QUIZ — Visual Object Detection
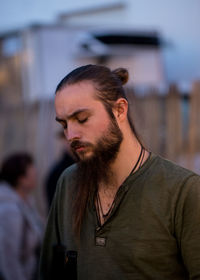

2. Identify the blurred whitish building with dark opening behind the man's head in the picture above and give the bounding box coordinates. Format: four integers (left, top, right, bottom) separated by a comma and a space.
0, 28, 165, 104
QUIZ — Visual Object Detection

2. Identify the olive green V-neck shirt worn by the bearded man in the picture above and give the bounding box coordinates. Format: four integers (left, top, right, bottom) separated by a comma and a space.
40, 154, 200, 280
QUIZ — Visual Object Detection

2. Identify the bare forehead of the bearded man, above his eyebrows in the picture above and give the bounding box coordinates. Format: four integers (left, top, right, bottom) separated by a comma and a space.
55, 81, 103, 116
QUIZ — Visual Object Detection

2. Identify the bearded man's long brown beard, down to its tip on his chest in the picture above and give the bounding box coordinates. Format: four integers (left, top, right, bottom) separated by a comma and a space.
71, 111, 123, 237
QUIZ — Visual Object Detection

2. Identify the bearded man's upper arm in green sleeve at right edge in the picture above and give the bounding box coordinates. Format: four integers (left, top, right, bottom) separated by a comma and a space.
176, 176, 200, 279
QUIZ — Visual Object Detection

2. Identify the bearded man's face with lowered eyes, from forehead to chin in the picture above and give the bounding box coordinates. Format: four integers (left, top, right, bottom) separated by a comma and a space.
55, 81, 122, 162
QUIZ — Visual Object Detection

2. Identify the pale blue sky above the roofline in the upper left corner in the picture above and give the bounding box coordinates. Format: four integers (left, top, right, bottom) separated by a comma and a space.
0, 0, 115, 33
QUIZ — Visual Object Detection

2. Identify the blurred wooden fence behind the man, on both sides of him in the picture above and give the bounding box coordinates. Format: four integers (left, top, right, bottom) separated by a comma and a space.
0, 82, 200, 214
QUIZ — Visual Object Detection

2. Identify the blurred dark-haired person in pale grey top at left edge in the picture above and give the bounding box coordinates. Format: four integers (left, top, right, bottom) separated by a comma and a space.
0, 152, 43, 280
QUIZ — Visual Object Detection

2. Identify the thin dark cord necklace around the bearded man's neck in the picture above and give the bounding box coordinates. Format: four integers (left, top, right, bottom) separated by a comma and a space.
96, 146, 145, 223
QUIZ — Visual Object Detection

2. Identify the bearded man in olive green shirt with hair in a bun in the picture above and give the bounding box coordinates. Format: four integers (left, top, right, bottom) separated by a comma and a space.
41, 65, 200, 280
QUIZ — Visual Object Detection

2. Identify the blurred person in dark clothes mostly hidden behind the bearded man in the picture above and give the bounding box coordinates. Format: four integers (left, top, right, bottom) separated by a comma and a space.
46, 130, 74, 209
